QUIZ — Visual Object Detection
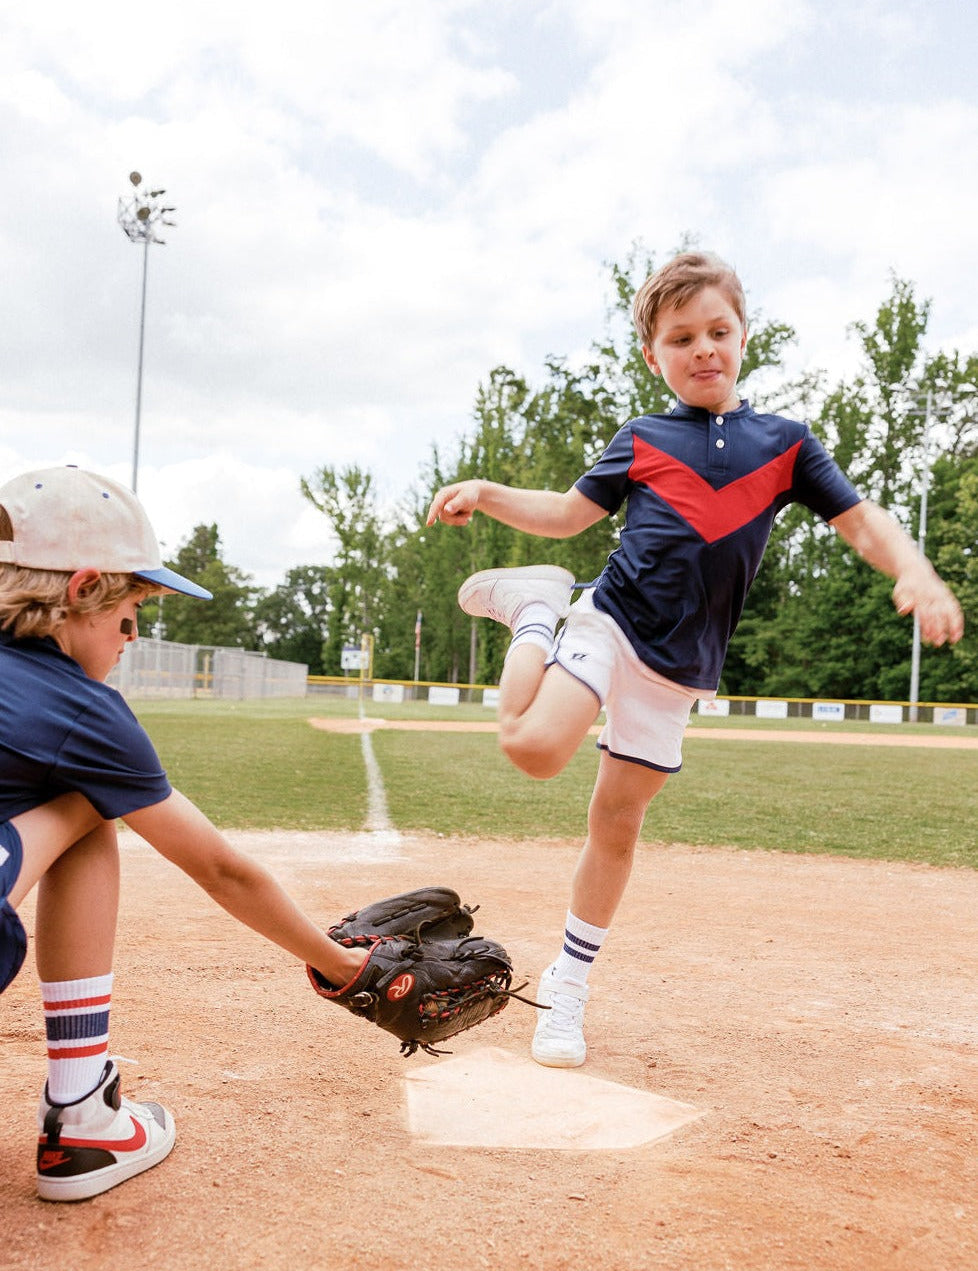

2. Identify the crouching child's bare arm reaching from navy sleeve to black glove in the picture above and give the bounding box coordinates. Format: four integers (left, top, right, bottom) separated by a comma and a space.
123, 791, 364, 984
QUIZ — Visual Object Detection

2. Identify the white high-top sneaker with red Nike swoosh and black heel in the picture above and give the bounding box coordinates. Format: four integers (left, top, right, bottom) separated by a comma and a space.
37, 1060, 176, 1200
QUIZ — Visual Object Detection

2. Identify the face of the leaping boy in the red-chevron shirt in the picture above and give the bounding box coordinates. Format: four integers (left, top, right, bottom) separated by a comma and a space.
642, 287, 747, 414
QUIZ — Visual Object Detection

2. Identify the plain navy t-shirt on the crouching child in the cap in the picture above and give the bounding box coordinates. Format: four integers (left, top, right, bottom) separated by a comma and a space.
0, 632, 170, 821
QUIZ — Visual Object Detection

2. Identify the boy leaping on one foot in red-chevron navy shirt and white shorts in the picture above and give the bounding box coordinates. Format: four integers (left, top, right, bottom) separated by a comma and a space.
427, 253, 964, 1068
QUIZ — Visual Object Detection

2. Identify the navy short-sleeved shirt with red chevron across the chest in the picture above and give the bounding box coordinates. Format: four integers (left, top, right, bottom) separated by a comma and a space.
576, 402, 861, 690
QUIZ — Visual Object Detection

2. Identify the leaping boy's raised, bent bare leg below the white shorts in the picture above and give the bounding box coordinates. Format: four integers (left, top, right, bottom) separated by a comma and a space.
499, 644, 600, 780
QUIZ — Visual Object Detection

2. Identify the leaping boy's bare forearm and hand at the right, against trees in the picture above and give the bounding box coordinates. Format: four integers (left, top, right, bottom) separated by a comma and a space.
830, 498, 964, 646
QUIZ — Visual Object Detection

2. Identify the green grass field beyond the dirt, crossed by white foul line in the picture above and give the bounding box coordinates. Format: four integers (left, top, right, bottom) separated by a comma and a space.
134, 697, 978, 868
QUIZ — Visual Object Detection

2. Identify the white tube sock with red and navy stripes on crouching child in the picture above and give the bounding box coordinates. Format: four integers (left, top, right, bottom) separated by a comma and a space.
41, 974, 112, 1103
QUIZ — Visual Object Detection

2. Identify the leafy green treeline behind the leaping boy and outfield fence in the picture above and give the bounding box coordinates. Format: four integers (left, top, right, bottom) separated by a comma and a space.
146, 252, 978, 702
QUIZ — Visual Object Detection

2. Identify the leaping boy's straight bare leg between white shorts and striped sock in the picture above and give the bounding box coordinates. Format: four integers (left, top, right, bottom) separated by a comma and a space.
571, 751, 669, 927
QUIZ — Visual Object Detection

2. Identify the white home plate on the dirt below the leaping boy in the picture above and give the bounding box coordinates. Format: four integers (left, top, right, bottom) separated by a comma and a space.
404, 1047, 703, 1152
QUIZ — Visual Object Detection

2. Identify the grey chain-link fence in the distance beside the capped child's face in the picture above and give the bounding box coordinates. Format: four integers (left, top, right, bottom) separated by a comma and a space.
107, 639, 309, 699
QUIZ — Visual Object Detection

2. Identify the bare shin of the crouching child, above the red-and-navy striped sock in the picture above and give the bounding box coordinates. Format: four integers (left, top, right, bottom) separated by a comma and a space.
34, 821, 120, 982
